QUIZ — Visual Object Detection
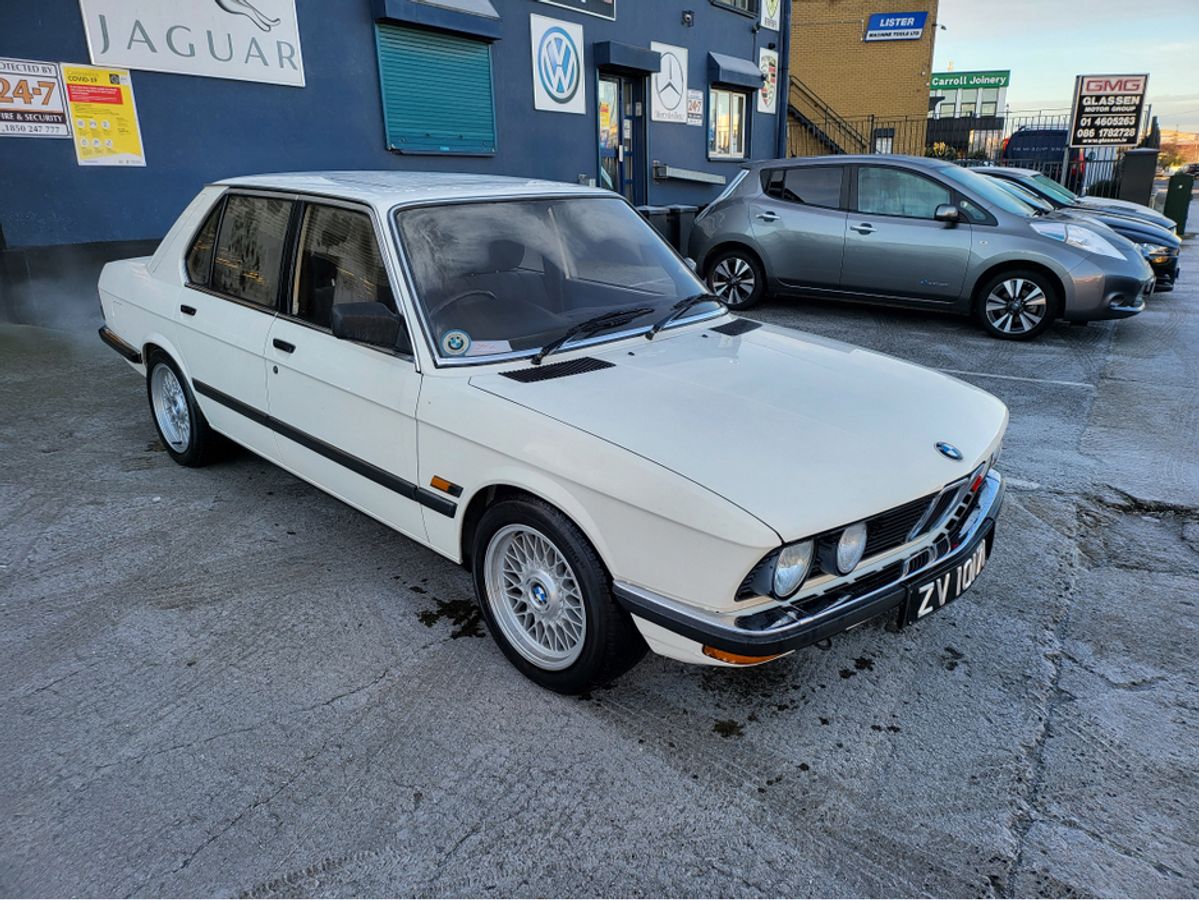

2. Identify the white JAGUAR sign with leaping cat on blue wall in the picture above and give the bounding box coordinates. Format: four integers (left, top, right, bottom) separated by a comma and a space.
79, 0, 303, 87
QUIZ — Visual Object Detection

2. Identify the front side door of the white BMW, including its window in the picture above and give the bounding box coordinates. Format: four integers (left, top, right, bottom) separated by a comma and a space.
266, 200, 426, 540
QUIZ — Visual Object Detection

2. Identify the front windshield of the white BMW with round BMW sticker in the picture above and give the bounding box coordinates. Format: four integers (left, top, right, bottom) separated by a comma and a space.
396, 197, 721, 358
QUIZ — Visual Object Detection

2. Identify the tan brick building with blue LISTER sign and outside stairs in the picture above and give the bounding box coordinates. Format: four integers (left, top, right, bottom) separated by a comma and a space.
789, 0, 938, 156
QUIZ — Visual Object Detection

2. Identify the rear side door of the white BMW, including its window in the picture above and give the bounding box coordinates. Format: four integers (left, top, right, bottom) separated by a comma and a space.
174, 192, 295, 458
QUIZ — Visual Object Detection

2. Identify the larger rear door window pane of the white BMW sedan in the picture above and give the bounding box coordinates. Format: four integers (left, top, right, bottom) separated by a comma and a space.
211, 194, 293, 309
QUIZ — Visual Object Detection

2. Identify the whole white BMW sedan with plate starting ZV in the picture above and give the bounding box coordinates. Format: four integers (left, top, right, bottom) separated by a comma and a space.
100, 171, 1007, 693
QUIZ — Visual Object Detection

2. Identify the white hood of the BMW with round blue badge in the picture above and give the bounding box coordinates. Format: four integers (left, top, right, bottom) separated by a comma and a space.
470, 320, 1007, 540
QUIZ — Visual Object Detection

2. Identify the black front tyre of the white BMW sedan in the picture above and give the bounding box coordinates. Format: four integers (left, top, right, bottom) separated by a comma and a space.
471, 499, 646, 694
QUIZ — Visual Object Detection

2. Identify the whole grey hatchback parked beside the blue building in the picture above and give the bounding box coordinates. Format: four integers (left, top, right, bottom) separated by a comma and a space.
689, 156, 1153, 340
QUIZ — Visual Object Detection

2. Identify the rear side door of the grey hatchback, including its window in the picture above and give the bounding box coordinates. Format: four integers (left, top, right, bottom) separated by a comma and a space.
749, 165, 845, 288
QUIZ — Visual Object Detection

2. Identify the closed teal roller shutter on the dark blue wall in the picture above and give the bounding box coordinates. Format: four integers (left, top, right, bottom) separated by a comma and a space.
375, 24, 495, 156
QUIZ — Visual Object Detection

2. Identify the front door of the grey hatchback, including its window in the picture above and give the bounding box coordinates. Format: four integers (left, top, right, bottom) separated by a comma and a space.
842, 165, 972, 301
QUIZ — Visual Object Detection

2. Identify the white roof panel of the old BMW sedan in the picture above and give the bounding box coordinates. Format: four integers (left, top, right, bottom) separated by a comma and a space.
216, 170, 604, 207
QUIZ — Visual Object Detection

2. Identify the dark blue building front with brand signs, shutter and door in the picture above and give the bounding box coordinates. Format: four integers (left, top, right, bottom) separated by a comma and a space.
0, 0, 789, 250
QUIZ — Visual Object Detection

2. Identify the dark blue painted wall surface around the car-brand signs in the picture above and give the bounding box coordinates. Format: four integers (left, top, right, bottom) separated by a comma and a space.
0, 0, 789, 247
